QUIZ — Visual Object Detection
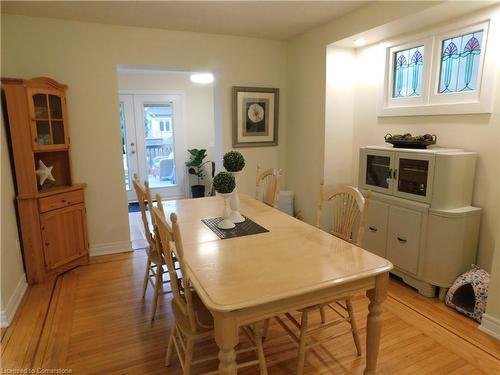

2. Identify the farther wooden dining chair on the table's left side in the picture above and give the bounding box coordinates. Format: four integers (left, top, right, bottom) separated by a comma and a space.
132, 174, 171, 320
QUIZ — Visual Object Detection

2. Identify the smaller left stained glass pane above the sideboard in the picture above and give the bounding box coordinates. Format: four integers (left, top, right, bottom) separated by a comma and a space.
392, 46, 424, 98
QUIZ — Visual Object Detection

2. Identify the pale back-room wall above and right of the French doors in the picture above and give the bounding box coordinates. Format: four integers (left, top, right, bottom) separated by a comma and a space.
118, 69, 216, 192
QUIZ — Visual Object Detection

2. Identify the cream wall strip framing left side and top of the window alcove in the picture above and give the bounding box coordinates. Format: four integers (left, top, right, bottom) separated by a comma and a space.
285, 1, 436, 228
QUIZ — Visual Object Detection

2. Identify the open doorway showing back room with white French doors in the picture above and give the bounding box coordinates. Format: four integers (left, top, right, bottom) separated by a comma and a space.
117, 65, 223, 253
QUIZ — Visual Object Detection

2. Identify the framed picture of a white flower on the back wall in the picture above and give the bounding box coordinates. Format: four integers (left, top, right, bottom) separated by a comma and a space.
233, 86, 279, 148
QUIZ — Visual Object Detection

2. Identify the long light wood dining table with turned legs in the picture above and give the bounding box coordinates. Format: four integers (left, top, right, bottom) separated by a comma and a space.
163, 194, 392, 375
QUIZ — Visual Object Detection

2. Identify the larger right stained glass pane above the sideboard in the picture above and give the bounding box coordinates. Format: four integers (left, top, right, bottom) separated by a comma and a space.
439, 30, 484, 94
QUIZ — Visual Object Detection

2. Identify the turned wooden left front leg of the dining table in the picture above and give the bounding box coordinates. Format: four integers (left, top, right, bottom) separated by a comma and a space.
214, 313, 239, 375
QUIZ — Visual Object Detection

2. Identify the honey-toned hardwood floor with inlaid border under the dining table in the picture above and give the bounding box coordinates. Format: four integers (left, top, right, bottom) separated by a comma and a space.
1, 251, 500, 375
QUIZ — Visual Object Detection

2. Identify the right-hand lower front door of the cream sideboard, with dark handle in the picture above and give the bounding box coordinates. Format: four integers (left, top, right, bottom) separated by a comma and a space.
387, 206, 422, 275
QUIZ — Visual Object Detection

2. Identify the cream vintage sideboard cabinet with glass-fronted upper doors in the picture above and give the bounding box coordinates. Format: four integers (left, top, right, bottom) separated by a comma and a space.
359, 146, 481, 299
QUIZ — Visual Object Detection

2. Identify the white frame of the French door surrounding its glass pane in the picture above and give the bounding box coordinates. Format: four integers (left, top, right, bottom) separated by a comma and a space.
119, 90, 188, 201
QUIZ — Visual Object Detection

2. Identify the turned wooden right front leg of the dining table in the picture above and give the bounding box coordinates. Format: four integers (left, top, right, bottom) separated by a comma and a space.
364, 272, 389, 375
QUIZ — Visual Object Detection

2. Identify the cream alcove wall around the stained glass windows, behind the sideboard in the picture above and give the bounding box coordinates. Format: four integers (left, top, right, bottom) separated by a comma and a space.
352, 7, 500, 270
